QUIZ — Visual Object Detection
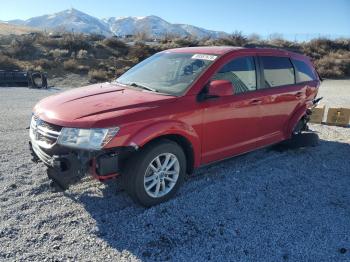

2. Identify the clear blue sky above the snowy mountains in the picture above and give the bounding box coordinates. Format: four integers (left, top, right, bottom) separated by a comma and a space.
0, 0, 350, 40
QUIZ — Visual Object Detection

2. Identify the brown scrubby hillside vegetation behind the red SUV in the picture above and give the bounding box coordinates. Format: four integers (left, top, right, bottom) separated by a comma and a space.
0, 33, 350, 82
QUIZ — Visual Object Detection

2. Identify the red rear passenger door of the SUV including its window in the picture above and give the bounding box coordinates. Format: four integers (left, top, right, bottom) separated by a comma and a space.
257, 55, 304, 146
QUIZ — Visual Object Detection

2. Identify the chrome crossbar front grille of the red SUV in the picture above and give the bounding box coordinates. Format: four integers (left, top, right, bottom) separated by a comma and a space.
30, 115, 62, 149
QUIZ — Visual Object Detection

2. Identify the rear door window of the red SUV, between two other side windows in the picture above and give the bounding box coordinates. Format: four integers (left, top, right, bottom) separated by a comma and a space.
260, 56, 295, 88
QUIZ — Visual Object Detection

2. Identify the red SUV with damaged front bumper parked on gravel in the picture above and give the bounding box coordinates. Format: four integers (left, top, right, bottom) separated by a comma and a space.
30, 47, 320, 206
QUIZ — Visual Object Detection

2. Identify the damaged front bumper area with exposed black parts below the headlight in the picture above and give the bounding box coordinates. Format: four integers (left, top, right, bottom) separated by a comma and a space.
29, 140, 135, 190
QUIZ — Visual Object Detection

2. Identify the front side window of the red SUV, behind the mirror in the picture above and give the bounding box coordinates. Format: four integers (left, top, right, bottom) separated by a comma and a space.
213, 57, 256, 94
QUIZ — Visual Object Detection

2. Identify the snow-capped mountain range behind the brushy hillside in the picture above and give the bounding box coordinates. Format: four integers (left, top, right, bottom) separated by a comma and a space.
8, 9, 227, 38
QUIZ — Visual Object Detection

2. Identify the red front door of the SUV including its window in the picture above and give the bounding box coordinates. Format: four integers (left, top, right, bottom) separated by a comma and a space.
202, 56, 260, 164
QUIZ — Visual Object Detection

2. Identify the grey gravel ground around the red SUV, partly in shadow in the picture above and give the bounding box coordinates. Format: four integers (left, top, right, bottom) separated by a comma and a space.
0, 81, 350, 261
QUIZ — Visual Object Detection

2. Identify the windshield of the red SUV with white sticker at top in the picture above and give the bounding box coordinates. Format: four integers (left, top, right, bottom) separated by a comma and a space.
116, 52, 216, 95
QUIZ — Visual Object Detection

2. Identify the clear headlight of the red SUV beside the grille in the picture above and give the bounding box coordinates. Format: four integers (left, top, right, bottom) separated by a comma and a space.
57, 127, 119, 150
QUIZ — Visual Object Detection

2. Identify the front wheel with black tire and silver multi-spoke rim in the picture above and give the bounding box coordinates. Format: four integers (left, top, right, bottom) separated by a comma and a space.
123, 139, 186, 207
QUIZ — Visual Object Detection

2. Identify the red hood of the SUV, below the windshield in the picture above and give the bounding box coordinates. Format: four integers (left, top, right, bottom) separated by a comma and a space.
34, 83, 177, 127
